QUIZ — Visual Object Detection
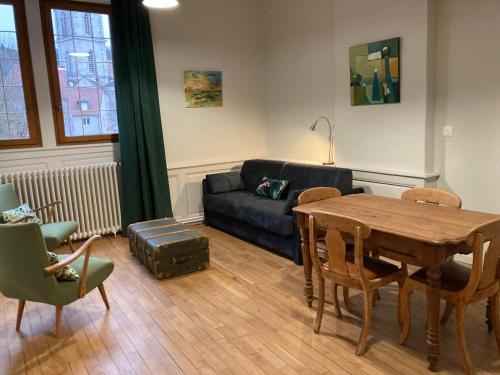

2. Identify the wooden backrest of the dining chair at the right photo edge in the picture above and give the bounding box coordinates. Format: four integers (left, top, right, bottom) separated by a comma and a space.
464, 219, 500, 297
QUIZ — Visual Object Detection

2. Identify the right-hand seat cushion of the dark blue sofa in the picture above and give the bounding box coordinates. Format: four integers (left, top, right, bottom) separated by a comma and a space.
238, 196, 294, 236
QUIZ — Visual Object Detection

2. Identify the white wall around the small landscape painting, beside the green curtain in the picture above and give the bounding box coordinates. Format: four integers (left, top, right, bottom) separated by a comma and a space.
150, 0, 266, 168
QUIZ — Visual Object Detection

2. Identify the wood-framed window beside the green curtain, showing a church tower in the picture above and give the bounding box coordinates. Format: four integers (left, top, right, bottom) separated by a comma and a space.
40, 0, 118, 144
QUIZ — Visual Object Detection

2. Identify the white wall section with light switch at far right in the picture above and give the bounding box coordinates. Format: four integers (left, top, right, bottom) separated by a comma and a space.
435, 0, 500, 213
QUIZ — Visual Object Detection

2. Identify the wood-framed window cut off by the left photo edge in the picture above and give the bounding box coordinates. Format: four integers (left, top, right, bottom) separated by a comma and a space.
0, 0, 41, 148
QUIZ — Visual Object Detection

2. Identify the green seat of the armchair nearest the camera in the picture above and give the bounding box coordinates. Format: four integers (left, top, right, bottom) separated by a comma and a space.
50, 254, 115, 306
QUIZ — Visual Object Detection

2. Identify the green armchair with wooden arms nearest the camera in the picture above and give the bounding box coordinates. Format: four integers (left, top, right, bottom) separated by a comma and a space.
0, 223, 114, 336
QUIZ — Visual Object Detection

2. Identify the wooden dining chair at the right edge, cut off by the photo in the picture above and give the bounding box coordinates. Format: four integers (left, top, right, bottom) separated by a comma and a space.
399, 220, 500, 374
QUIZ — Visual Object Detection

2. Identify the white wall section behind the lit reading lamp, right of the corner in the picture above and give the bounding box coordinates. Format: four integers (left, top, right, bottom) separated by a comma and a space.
263, 0, 335, 161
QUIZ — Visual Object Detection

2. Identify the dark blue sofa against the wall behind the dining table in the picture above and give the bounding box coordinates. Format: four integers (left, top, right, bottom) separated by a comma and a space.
203, 159, 363, 264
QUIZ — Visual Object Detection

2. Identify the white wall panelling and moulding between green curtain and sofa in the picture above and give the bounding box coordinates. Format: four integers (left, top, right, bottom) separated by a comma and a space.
168, 160, 243, 223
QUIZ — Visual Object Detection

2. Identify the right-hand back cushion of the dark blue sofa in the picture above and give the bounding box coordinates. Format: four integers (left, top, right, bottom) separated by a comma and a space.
279, 163, 352, 195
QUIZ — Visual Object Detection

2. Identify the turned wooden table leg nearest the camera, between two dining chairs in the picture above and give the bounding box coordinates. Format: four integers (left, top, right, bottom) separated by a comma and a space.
426, 264, 441, 371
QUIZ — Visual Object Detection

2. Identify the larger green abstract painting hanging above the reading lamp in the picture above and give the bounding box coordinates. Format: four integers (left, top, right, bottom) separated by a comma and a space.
349, 38, 401, 105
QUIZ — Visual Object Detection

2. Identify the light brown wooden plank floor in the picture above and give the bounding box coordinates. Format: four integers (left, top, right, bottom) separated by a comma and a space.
0, 226, 500, 375
